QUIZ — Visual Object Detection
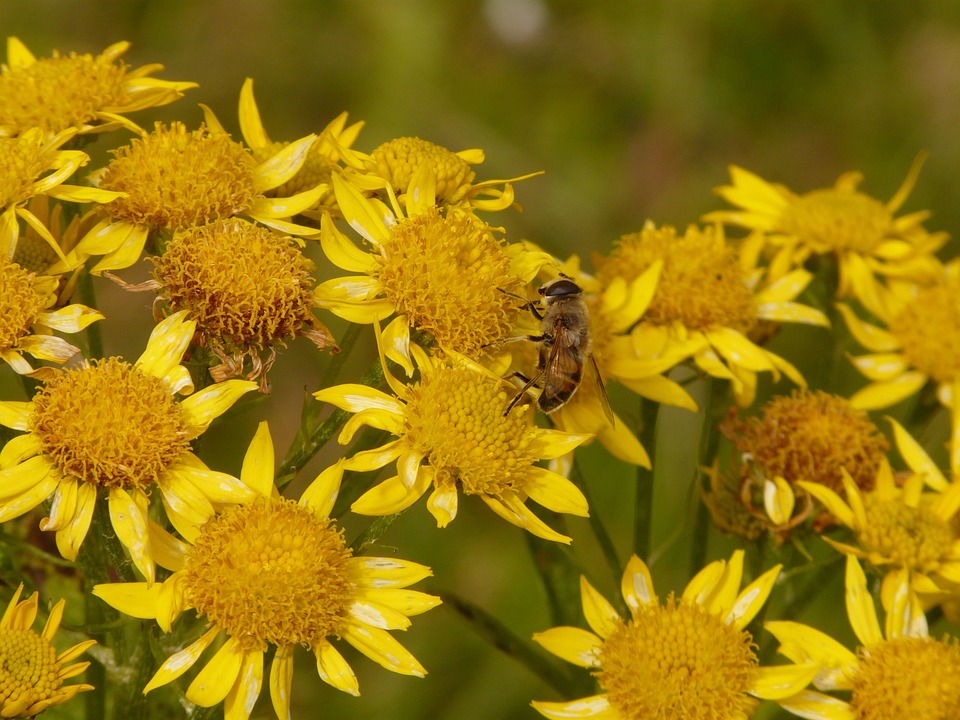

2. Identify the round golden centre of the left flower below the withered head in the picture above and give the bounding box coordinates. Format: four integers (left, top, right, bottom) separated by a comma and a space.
31, 358, 191, 489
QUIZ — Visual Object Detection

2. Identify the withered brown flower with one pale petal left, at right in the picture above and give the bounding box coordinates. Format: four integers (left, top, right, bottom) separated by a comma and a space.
720, 390, 889, 539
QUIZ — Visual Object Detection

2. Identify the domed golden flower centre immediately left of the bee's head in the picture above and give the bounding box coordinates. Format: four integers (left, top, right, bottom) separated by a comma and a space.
376, 208, 522, 357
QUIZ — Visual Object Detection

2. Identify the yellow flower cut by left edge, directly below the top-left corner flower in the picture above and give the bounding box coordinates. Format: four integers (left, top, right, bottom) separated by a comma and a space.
0, 127, 123, 257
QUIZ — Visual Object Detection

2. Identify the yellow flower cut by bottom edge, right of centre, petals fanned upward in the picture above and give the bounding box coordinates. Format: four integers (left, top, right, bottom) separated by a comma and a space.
532, 550, 818, 720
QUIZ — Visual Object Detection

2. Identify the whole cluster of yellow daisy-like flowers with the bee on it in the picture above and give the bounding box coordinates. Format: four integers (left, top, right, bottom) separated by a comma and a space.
0, 32, 960, 720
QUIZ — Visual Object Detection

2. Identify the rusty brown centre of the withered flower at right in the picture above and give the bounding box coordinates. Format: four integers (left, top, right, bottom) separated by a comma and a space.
721, 390, 889, 492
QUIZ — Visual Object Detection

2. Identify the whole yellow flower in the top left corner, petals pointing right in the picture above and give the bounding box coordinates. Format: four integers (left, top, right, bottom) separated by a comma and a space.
0, 37, 197, 136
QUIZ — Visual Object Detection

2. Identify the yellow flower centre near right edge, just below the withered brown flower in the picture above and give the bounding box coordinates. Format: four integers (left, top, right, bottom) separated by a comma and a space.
859, 494, 956, 572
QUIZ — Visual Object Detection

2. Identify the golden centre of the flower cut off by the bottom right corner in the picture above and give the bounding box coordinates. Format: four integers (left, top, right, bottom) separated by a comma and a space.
850, 637, 960, 720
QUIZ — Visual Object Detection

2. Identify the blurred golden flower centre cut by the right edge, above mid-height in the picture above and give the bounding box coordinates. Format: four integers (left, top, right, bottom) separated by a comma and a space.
890, 280, 960, 383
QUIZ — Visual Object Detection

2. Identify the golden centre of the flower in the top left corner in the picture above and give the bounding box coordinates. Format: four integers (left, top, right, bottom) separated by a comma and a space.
0, 52, 126, 136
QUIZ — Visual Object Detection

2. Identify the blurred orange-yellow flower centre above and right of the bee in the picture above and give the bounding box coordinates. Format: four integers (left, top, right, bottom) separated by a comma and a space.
595, 224, 757, 333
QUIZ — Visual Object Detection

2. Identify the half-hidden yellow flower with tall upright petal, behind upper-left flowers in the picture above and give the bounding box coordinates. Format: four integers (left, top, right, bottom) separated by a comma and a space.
201, 78, 365, 214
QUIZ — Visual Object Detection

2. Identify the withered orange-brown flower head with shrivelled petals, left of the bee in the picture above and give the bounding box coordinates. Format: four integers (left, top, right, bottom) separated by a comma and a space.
137, 218, 336, 392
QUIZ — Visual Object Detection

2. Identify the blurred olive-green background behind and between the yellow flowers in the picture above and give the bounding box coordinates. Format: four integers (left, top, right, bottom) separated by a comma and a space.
0, 0, 960, 720
